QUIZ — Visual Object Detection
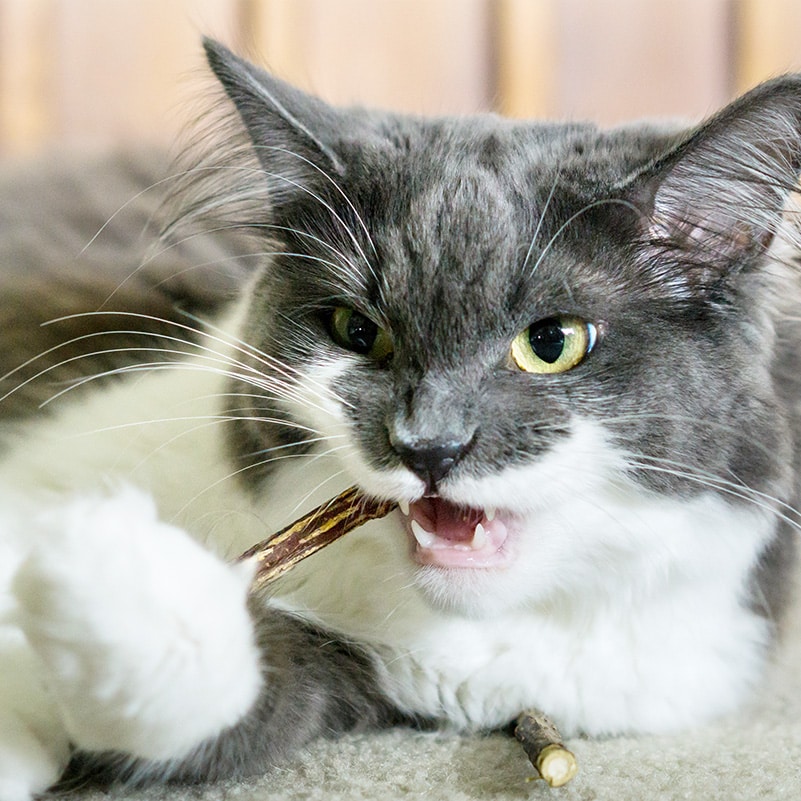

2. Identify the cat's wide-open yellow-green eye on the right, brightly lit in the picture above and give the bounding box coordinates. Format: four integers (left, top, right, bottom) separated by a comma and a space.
511, 315, 597, 373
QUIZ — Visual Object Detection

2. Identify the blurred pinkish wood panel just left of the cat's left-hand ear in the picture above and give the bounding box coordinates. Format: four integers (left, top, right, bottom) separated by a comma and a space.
47, 0, 236, 144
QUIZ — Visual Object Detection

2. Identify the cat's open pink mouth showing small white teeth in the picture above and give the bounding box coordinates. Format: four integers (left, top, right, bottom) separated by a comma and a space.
401, 497, 511, 568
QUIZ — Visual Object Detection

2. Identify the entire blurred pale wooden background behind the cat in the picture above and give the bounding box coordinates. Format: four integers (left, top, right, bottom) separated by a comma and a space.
0, 0, 801, 155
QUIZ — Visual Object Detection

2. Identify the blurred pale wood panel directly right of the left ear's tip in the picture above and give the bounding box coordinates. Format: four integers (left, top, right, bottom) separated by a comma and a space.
246, 0, 493, 114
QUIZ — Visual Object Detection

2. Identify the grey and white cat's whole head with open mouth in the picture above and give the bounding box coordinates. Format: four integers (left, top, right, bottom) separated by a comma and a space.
194, 43, 801, 608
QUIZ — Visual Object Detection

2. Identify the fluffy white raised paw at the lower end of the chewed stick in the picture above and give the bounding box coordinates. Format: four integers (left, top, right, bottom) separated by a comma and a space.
14, 488, 261, 759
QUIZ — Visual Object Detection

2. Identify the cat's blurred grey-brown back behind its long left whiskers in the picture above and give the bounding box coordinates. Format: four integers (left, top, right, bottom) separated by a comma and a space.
0, 149, 250, 420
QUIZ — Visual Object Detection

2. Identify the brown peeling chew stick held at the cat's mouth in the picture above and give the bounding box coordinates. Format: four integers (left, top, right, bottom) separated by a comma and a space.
239, 487, 397, 590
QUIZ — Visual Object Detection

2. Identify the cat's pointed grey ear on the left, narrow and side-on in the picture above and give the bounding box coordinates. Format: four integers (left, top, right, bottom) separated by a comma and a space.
203, 39, 370, 206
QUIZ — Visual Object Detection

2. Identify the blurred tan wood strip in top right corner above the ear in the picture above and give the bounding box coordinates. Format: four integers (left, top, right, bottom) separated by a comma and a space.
734, 0, 801, 92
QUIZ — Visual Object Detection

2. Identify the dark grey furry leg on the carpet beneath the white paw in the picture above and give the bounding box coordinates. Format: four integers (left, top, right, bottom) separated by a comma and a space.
59, 605, 406, 789
